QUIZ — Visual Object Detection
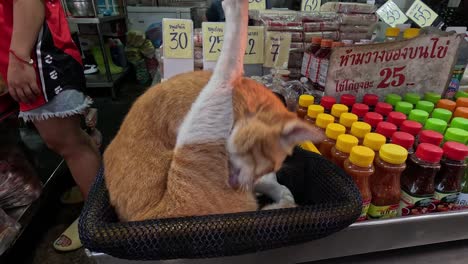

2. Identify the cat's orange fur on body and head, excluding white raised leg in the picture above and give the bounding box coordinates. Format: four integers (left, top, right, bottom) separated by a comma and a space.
104, 71, 322, 221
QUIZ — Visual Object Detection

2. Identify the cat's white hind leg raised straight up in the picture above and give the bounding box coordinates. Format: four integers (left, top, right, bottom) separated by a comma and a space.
176, 0, 249, 146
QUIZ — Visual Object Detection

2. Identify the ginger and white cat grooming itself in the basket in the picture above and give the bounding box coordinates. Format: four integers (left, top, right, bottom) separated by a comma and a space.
104, 0, 323, 221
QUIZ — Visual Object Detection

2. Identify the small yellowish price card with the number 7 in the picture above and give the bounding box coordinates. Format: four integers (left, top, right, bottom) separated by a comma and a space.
263, 31, 291, 69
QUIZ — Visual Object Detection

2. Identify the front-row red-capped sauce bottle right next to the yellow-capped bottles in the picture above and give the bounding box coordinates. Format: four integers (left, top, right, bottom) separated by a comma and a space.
399, 143, 443, 216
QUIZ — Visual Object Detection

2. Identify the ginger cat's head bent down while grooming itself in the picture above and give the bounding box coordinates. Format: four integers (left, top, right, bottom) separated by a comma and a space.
227, 114, 324, 190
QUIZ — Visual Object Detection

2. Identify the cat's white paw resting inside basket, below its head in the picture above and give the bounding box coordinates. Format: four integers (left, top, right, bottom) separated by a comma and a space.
254, 173, 296, 210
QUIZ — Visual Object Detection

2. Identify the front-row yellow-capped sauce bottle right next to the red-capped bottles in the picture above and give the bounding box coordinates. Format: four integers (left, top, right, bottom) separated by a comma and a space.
367, 144, 408, 219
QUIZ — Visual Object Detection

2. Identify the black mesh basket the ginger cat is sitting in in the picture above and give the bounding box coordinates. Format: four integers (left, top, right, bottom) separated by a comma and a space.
79, 148, 362, 260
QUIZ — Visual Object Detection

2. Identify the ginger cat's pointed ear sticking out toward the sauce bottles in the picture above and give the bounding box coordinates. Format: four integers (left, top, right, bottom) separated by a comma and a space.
280, 119, 325, 154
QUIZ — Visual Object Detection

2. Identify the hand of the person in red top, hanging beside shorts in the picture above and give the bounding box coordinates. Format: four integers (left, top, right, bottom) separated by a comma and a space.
7, 54, 41, 104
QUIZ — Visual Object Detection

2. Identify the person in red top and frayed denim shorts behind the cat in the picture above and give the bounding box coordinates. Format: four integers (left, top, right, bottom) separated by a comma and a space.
0, 0, 101, 250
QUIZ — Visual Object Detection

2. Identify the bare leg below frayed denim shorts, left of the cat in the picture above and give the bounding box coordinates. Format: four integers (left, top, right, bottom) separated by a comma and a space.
34, 116, 101, 199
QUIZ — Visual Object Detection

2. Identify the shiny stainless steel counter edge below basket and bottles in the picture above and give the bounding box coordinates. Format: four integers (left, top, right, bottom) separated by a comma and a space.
87, 211, 468, 264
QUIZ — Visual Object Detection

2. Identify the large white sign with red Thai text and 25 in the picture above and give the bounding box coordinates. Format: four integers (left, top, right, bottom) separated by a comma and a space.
325, 34, 463, 99
